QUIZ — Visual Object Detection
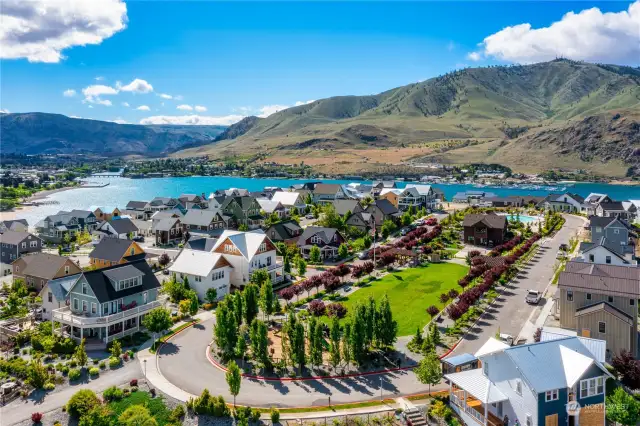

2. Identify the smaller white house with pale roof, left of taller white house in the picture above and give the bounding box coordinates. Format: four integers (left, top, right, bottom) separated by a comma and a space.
169, 249, 233, 300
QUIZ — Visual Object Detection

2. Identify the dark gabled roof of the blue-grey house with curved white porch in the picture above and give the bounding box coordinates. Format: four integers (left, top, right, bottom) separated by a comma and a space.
83, 260, 160, 303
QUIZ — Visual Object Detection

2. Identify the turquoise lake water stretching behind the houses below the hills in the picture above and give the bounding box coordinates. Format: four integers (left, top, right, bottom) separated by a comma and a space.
10, 176, 640, 225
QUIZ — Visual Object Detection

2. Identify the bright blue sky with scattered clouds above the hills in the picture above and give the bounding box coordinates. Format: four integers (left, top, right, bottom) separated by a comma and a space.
0, 0, 640, 124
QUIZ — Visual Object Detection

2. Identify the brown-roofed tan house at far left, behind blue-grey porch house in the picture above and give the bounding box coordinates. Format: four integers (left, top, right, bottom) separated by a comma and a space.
11, 253, 82, 291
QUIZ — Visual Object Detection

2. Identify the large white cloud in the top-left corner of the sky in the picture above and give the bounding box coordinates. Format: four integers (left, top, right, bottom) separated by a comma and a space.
0, 0, 127, 63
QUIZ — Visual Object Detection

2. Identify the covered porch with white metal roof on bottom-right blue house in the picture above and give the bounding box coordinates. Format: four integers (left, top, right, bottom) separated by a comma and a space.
445, 369, 508, 426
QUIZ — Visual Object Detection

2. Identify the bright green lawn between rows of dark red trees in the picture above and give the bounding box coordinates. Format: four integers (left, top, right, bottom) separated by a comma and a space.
342, 263, 468, 336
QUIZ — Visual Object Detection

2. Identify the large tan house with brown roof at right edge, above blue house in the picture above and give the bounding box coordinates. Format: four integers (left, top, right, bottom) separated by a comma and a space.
556, 261, 640, 358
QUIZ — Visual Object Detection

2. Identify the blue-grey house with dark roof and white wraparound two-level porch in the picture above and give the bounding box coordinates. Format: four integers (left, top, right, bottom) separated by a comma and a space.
52, 260, 164, 347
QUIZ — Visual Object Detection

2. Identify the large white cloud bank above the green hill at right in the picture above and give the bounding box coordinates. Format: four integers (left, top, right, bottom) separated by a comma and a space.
468, 0, 640, 65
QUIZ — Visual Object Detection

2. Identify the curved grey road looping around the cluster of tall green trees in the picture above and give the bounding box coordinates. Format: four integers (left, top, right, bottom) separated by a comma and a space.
158, 320, 436, 407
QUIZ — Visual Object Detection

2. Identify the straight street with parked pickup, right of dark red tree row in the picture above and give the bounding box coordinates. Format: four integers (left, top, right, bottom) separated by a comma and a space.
455, 215, 584, 354
